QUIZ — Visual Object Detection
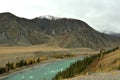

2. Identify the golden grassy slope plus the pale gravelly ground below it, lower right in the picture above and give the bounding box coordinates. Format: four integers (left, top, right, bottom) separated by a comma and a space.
65, 50, 120, 80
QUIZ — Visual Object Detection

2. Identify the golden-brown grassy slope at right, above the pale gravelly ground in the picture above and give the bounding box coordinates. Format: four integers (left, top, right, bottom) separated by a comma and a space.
83, 50, 120, 73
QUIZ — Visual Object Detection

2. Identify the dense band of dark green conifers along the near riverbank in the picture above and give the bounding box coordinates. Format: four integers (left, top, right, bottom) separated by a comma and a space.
52, 47, 119, 80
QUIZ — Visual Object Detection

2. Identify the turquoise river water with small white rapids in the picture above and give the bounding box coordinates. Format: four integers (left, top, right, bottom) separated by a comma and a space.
3, 56, 83, 80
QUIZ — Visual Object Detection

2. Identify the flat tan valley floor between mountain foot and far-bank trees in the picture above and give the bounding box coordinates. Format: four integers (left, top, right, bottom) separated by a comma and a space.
0, 45, 97, 66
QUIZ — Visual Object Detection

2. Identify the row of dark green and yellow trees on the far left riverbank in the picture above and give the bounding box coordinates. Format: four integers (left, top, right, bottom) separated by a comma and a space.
0, 56, 47, 74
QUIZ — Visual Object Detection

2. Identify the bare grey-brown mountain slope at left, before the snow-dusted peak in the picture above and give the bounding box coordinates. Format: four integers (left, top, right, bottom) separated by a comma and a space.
0, 13, 53, 45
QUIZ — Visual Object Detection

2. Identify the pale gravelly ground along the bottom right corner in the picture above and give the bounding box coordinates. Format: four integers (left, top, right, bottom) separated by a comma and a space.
65, 71, 120, 80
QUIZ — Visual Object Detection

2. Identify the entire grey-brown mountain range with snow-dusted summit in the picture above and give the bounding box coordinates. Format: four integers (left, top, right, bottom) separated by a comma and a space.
0, 13, 120, 48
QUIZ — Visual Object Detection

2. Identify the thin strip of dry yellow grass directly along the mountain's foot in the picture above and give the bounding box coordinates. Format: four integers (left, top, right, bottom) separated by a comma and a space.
0, 45, 95, 54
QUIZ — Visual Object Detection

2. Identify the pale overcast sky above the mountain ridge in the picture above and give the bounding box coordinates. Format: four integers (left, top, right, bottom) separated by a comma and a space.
0, 0, 120, 32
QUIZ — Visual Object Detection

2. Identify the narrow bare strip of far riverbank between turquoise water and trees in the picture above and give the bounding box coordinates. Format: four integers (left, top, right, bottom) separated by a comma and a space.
0, 55, 85, 80
